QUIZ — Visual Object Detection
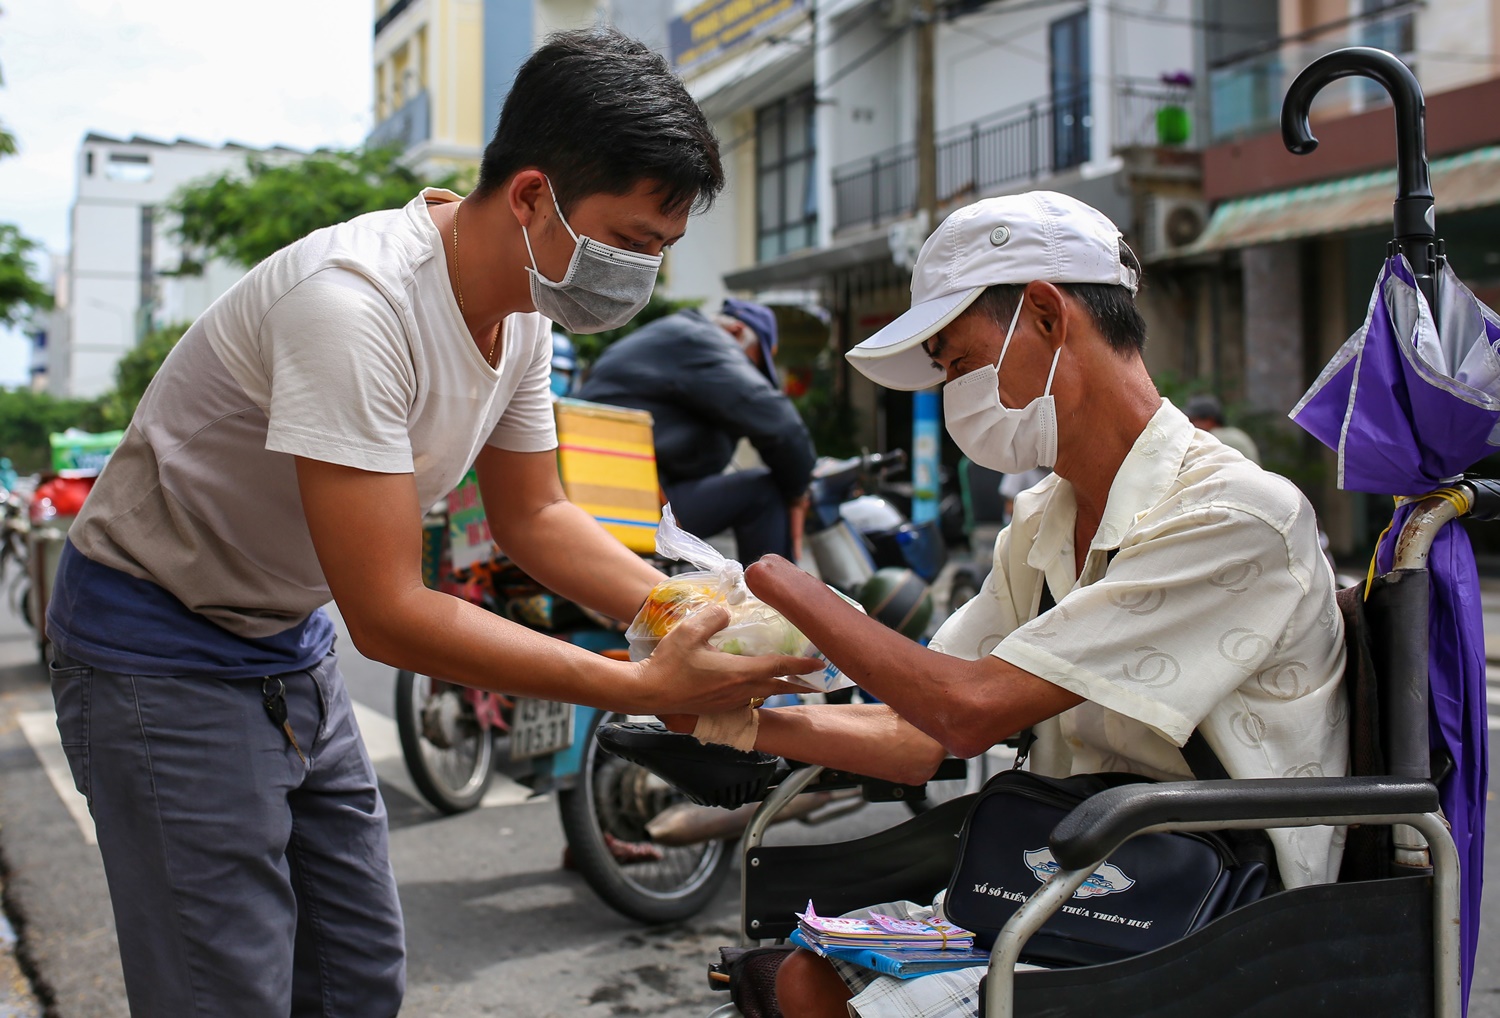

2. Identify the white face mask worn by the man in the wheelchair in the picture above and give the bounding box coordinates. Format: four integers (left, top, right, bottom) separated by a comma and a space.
942, 301, 1062, 474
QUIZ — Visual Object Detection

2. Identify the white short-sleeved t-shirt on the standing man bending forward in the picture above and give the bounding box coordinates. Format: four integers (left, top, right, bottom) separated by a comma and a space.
69, 189, 557, 637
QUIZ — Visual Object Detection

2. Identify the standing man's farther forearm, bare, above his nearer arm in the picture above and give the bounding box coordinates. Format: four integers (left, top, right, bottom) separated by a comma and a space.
491, 501, 665, 622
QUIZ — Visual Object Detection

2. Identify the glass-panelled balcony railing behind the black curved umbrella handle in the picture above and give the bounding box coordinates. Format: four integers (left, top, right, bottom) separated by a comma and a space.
1209, 4, 1416, 142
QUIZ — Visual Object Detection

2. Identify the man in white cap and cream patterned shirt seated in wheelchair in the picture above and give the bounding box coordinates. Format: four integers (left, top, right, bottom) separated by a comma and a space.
669, 192, 1349, 1018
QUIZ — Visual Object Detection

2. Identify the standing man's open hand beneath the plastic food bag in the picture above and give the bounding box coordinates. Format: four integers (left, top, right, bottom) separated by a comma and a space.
639, 604, 824, 714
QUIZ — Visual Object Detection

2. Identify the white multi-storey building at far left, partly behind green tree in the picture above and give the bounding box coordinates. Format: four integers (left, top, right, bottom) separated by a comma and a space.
47, 133, 300, 397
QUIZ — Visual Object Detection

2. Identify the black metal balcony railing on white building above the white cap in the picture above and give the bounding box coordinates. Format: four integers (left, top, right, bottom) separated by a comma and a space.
834, 82, 1188, 231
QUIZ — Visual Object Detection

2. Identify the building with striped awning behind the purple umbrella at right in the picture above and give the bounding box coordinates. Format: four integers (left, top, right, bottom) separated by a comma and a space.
1148, 0, 1500, 556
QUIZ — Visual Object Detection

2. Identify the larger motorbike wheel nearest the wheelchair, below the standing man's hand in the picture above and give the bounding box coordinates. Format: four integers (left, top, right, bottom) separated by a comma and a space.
558, 712, 732, 924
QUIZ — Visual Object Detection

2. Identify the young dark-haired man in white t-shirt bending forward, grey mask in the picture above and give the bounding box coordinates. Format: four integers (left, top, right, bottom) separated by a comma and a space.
48, 33, 812, 1018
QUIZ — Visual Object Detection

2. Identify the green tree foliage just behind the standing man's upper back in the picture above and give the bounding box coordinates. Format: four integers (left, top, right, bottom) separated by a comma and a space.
170, 147, 458, 274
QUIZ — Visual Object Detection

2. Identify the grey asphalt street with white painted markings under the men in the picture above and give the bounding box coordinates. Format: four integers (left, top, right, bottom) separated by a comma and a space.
0, 592, 1500, 1018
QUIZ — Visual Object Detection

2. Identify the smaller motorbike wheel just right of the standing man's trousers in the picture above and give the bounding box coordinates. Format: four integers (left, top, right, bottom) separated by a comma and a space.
396, 669, 495, 816
